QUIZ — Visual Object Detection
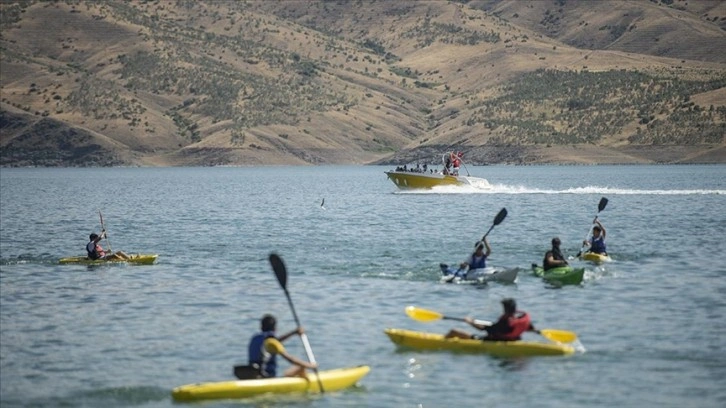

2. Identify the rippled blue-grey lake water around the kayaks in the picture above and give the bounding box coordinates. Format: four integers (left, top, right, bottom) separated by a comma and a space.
0, 165, 726, 408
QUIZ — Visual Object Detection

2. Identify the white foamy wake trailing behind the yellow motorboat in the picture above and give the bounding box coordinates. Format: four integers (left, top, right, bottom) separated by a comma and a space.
396, 184, 726, 195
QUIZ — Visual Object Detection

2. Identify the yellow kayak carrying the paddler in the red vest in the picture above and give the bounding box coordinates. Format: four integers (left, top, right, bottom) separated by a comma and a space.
384, 329, 575, 357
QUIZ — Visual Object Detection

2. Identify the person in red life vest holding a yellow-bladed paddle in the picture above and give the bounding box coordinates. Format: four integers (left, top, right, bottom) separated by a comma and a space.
446, 298, 539, 341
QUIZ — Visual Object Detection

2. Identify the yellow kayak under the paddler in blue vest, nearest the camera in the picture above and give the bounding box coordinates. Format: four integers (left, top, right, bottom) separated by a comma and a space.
171, 365, 370, 402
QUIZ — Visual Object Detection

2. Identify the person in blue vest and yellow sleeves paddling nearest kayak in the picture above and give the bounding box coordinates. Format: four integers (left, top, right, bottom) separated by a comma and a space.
248, 314, 318, 378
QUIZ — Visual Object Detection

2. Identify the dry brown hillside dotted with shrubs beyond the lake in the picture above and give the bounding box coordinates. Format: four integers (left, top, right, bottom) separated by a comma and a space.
0, 0, 726, 166
